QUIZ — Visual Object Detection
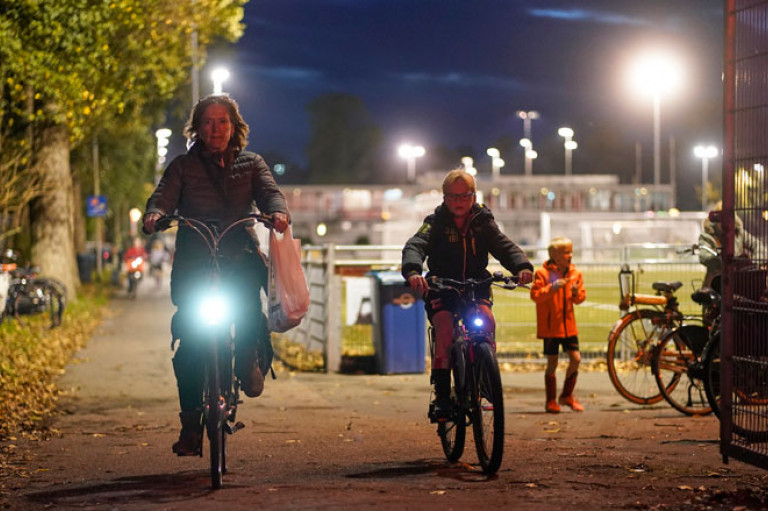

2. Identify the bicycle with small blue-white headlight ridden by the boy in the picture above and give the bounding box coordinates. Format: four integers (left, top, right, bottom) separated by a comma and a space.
429, 272, 518, 474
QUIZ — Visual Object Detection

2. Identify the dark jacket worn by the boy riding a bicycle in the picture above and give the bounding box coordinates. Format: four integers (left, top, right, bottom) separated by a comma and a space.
402, 204, 533, 280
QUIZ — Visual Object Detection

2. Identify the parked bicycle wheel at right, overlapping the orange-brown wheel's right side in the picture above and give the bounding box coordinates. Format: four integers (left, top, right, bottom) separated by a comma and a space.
653, 326, 712, 415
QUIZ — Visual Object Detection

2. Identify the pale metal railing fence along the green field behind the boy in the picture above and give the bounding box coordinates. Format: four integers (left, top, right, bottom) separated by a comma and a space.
282, 244, 704, 371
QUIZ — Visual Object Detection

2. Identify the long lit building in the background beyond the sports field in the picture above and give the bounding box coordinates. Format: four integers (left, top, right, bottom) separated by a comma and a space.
282, 172, 703, 251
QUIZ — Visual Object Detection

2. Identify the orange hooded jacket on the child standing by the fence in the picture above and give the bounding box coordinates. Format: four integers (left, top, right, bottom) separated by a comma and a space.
531, 261, 587, 339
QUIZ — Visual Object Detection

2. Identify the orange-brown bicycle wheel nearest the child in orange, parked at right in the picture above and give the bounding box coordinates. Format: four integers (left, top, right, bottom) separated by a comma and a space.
606, 309, 666, 405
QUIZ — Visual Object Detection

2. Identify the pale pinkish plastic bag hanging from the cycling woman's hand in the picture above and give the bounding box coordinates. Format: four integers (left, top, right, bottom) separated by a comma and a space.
267, 228, 309, 332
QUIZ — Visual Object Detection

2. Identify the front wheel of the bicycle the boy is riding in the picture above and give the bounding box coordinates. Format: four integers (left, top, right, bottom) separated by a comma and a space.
472, 343, 504, 474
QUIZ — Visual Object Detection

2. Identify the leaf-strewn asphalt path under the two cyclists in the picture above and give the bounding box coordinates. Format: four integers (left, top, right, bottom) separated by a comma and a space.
0, 282, 766, 511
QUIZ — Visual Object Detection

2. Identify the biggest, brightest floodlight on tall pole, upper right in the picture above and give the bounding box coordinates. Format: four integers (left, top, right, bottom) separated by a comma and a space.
630, 54, 681, 185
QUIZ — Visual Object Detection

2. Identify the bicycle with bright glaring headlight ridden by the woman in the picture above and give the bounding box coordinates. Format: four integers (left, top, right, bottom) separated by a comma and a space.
156, 214, 273, 489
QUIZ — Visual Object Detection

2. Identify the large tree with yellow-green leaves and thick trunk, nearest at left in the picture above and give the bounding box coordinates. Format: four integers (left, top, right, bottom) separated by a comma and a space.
0, 0, 246, 287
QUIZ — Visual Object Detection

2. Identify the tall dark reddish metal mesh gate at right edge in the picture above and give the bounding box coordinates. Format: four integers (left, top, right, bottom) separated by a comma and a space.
720, 0, 768, 468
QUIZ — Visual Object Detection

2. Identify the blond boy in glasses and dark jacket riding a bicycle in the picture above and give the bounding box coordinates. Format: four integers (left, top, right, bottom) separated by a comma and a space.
402, 169, 533, 420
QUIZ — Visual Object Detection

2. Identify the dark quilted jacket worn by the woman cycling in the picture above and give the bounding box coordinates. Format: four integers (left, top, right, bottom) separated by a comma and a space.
146, 142, 288, 280
